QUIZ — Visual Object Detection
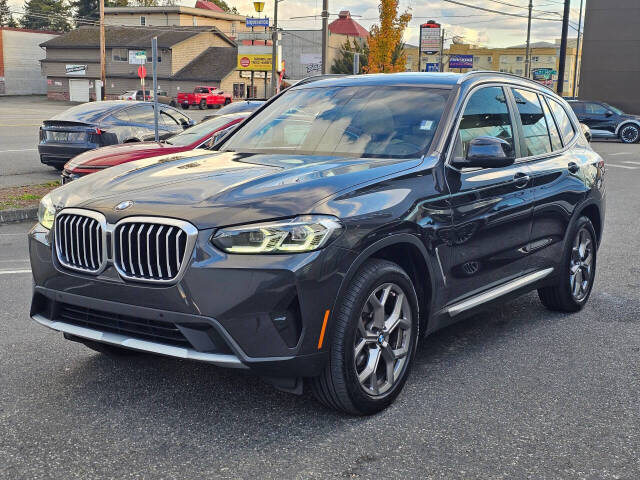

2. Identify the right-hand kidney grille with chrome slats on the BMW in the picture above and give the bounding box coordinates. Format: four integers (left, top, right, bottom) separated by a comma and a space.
113, 217, 197, 282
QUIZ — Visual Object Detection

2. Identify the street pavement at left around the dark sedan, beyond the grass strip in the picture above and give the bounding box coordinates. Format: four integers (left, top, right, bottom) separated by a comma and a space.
0, 96, 216, 188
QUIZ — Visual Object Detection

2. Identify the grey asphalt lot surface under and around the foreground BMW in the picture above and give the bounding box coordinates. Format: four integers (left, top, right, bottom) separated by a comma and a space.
0, 133, 640, 480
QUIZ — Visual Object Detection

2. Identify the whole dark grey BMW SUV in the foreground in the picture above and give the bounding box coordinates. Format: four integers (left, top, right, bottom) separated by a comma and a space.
29, 72, 605, 414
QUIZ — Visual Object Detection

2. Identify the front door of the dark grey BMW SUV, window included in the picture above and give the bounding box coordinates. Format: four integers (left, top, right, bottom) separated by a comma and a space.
444, 85, 533, 302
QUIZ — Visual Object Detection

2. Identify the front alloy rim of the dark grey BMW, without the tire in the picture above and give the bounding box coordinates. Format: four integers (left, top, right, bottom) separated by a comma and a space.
353, 283, 411, 396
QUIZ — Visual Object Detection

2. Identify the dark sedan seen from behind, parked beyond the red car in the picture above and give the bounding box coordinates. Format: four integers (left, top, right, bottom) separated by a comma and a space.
38, 100, 195, 170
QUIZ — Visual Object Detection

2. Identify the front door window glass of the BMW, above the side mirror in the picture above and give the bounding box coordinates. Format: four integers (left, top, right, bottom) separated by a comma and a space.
454, 87, 513, 158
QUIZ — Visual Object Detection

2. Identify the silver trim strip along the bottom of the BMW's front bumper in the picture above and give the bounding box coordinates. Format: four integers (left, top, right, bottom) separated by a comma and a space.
32, 314, 248, 368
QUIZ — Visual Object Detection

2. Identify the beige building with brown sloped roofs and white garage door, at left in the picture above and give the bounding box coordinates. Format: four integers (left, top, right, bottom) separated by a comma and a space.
40, 26, 249, 102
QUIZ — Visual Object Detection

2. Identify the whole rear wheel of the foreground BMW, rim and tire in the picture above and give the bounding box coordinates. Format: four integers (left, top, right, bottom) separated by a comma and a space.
538, 217, 597, 312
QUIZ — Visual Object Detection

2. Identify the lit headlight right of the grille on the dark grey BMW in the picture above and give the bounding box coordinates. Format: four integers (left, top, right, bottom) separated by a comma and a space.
211, 215, 342, 254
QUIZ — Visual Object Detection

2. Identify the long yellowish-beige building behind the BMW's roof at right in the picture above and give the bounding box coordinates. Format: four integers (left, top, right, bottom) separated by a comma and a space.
407, 39, 581, 96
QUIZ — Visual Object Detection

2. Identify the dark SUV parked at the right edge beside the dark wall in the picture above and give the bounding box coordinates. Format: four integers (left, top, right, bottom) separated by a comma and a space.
569, 100, 640, 143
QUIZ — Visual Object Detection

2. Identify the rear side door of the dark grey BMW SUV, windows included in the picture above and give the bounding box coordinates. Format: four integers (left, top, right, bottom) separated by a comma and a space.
514, 94, 590, 269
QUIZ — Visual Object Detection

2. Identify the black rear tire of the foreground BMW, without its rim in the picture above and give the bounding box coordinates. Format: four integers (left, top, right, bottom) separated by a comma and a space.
538, 217, 598, 313
